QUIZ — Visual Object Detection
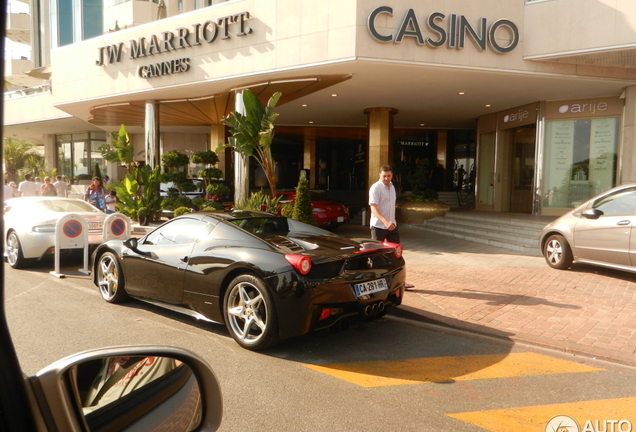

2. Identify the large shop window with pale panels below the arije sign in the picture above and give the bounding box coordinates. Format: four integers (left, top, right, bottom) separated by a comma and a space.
543, 118, 619, 208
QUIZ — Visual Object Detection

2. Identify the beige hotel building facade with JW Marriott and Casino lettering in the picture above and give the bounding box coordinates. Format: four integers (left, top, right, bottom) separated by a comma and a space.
4, 0, 636, 215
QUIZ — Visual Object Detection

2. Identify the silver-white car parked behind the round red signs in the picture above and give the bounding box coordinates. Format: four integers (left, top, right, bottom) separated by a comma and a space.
4, 196, 106, 268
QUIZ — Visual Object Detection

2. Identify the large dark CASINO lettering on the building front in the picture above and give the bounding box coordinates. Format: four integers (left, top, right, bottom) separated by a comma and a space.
367, 6, 519, 54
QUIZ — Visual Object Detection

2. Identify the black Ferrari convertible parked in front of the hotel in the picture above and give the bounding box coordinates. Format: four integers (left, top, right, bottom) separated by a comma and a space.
93, 211, 405, 350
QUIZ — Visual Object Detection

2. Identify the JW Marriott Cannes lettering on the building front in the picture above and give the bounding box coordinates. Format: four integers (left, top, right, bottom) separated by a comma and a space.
95, 12, 252, 78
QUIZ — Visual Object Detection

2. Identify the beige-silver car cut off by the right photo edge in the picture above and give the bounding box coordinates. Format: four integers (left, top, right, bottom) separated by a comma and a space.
539, 184, 636, 272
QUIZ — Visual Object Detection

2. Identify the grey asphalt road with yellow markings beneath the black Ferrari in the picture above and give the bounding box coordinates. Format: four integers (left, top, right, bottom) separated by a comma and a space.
5, 264, 636, 432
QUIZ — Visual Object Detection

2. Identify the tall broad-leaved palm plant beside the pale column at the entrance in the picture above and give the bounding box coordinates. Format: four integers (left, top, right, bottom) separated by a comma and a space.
217, 90, 281, 196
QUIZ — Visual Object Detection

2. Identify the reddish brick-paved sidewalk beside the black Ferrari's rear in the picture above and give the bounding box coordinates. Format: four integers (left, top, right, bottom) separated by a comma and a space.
337, 224, 636, 367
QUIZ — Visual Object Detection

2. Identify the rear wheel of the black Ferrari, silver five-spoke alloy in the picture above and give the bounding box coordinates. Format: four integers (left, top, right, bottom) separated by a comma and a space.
223, 275, 278, 351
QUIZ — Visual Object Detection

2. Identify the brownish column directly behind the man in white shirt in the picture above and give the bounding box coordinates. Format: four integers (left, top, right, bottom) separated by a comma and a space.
364, 107, 398, 189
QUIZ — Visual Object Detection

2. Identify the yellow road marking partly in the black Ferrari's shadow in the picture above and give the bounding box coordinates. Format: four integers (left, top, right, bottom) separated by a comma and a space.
305, 353, 602, 387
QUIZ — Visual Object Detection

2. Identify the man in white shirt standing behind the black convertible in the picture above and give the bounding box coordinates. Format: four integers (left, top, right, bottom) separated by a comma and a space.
369, 165, 400, 243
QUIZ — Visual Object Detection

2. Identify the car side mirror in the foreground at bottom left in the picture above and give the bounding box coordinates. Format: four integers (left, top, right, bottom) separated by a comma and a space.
27, 346, 223, 432
